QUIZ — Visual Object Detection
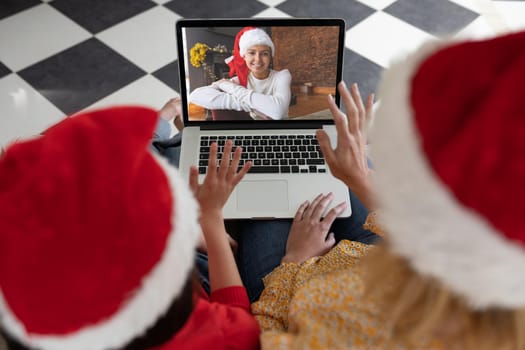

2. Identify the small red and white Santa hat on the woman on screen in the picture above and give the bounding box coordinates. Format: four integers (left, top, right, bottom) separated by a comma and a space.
225, 27, 275, 86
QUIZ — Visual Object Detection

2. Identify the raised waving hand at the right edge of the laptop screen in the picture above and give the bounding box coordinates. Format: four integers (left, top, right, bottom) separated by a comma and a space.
317, 82, 375, 210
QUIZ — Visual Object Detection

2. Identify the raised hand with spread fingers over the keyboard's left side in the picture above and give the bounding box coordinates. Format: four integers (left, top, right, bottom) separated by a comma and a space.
190, 140, 251, 217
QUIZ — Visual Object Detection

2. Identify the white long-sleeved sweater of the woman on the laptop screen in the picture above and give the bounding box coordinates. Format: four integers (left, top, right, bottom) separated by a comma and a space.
189, 69, 292, 119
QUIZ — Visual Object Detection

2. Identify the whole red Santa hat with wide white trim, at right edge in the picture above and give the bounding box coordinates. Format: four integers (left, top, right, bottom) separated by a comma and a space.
371, 32, 525, 309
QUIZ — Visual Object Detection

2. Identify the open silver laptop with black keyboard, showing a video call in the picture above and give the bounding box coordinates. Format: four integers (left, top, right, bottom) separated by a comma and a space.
176, 18, 351, 219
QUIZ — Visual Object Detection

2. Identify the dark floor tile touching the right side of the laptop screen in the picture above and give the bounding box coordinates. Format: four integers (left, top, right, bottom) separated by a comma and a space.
343, 49, 383, 106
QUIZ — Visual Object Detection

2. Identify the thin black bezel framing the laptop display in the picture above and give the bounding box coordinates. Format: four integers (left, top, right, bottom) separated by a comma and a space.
175, 18, 346, 129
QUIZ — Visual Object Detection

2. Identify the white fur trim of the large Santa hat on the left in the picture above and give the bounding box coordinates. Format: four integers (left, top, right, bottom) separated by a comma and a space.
0, 155, 200, 350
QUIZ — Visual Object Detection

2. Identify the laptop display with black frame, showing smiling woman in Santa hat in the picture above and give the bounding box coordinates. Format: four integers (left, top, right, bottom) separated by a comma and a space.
176, 18, 345, 125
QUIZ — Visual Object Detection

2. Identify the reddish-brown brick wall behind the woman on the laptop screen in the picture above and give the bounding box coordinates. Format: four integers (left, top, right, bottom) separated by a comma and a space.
271, 27, 338, 87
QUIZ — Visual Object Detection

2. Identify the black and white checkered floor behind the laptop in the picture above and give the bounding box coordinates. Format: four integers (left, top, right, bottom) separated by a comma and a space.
0, 0, 525, 146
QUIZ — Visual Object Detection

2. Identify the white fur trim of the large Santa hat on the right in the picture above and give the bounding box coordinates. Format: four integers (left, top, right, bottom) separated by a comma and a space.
371, 37, 525, 309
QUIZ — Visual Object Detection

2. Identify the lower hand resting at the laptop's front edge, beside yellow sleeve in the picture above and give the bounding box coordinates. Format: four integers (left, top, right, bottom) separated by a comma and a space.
282, 193, 346, 264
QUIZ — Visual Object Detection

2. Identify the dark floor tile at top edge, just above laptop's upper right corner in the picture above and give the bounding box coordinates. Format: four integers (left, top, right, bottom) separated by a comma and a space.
277, 0, 376, 29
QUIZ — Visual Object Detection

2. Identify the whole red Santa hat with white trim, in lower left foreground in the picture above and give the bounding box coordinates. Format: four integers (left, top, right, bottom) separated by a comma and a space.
0, 107, 200, 350
